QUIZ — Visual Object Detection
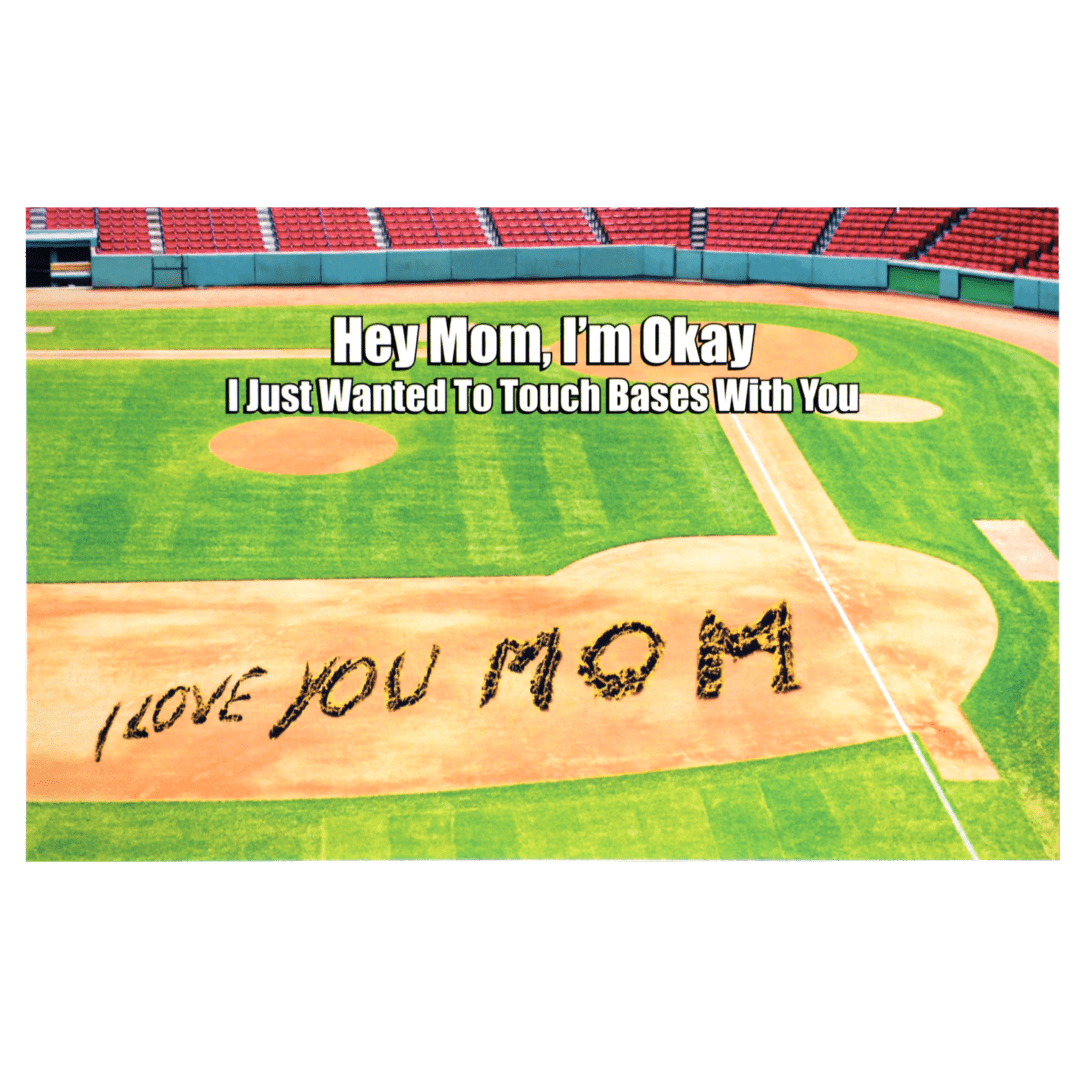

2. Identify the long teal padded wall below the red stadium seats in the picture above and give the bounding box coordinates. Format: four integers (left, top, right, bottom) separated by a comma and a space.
91, 244, 1058, 312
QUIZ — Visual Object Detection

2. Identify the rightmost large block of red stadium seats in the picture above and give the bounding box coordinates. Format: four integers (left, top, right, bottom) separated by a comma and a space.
921, 206, 1059, 278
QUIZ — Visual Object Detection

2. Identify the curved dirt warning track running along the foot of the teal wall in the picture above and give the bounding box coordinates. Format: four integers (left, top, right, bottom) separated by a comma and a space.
26, 281, 1061, 364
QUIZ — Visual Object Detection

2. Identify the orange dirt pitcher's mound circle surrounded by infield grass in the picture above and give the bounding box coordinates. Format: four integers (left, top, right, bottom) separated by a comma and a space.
210, 416, 397, 476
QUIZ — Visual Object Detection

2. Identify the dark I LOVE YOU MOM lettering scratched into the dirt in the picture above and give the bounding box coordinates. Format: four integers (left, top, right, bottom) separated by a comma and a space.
94, 600, 799, 761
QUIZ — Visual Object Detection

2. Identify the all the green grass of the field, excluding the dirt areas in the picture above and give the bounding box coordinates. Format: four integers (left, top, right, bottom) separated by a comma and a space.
27, 301, 1059, 858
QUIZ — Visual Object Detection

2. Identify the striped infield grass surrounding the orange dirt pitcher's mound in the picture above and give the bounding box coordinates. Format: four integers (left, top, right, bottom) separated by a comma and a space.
27, 324, 773, 581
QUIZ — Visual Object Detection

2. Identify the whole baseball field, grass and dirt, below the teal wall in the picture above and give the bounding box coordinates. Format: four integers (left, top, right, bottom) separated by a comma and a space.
26, 282, 1059, 860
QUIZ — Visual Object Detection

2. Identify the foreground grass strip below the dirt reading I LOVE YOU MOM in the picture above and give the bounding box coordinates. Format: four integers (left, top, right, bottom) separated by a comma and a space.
27, 738, 1002, 861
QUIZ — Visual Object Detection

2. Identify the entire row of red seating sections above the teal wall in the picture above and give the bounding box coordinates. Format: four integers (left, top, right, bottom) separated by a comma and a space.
24, 206, 1061, 280
